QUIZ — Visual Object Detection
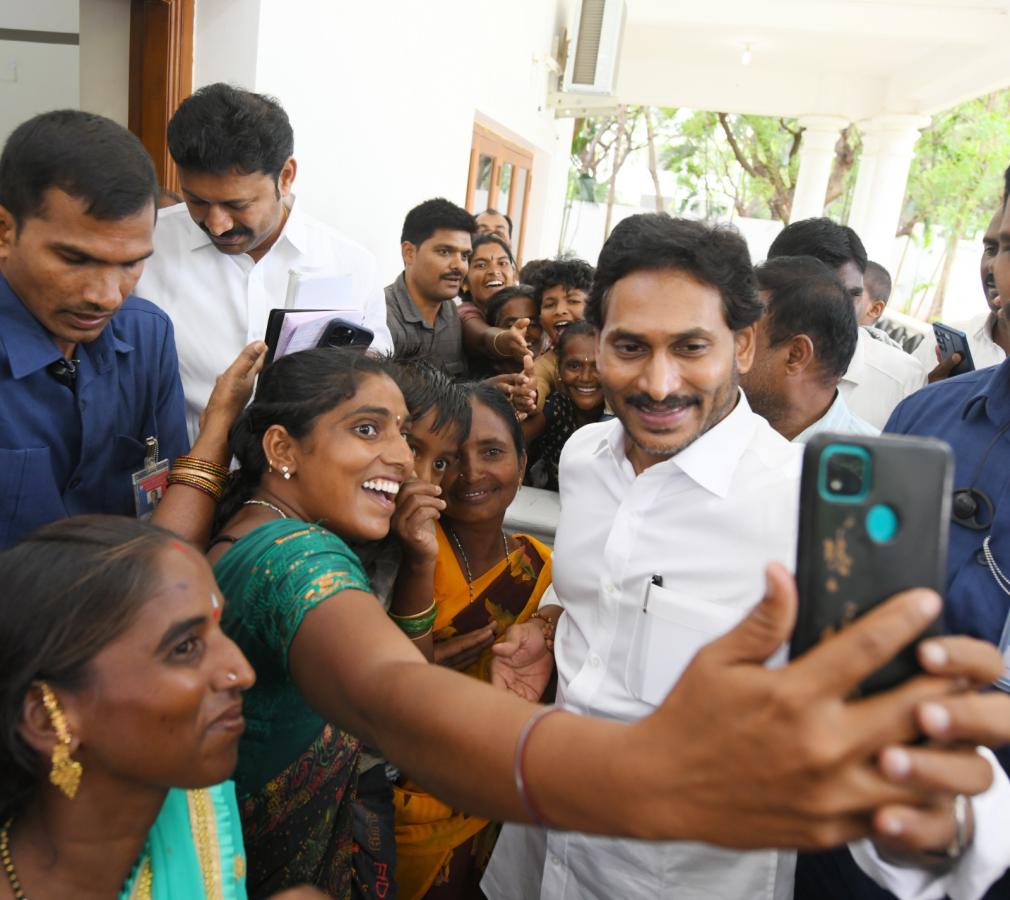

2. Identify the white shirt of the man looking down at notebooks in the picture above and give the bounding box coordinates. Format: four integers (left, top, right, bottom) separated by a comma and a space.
135, 201, 393, 440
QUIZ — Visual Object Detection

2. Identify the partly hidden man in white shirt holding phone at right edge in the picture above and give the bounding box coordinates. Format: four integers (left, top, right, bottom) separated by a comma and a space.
914, 209, 1010, 384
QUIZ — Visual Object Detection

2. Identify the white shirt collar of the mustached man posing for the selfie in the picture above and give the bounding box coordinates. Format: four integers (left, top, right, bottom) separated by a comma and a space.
593, 388, 756, 497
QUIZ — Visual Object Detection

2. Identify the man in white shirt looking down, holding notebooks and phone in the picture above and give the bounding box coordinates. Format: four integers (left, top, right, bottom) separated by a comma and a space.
137, 84, 393, 437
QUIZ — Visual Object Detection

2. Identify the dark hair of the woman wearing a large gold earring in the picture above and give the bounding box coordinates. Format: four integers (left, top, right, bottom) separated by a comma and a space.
0, 515, 179, 821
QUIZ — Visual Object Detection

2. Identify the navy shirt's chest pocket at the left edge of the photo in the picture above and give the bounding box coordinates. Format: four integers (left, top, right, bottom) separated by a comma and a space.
0, 446, 67, 546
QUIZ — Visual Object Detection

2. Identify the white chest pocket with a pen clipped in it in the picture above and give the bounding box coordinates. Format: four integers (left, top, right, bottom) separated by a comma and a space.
626, 584, 743, 706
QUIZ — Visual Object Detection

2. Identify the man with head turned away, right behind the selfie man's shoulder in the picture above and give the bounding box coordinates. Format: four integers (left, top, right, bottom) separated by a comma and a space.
740, 257, 880, 443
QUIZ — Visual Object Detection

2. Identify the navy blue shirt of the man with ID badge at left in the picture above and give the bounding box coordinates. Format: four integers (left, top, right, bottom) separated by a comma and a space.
0, 276, 189, 546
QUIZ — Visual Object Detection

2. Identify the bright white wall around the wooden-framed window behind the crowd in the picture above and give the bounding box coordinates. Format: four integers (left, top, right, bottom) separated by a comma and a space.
195, 0, 572, 281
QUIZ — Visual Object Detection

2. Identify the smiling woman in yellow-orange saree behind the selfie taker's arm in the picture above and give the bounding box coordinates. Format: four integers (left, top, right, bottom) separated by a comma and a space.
394, 385, 550, 900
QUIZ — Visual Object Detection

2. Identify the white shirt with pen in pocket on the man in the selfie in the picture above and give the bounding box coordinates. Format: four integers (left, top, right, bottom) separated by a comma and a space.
481, 393, 1010, 900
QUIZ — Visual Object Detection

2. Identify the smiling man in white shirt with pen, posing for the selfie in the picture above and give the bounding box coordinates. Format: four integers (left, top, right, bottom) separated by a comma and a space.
482, 214, 1010, 900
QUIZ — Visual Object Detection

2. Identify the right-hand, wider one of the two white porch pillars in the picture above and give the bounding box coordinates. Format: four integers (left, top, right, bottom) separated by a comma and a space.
848, 114, 930, 270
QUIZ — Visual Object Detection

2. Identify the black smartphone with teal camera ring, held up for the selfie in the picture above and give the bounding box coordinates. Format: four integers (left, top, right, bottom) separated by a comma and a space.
790, 433, 953, 694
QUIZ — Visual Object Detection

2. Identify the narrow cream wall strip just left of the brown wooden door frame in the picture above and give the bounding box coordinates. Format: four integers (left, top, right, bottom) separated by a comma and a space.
81, 0, 130, 127
